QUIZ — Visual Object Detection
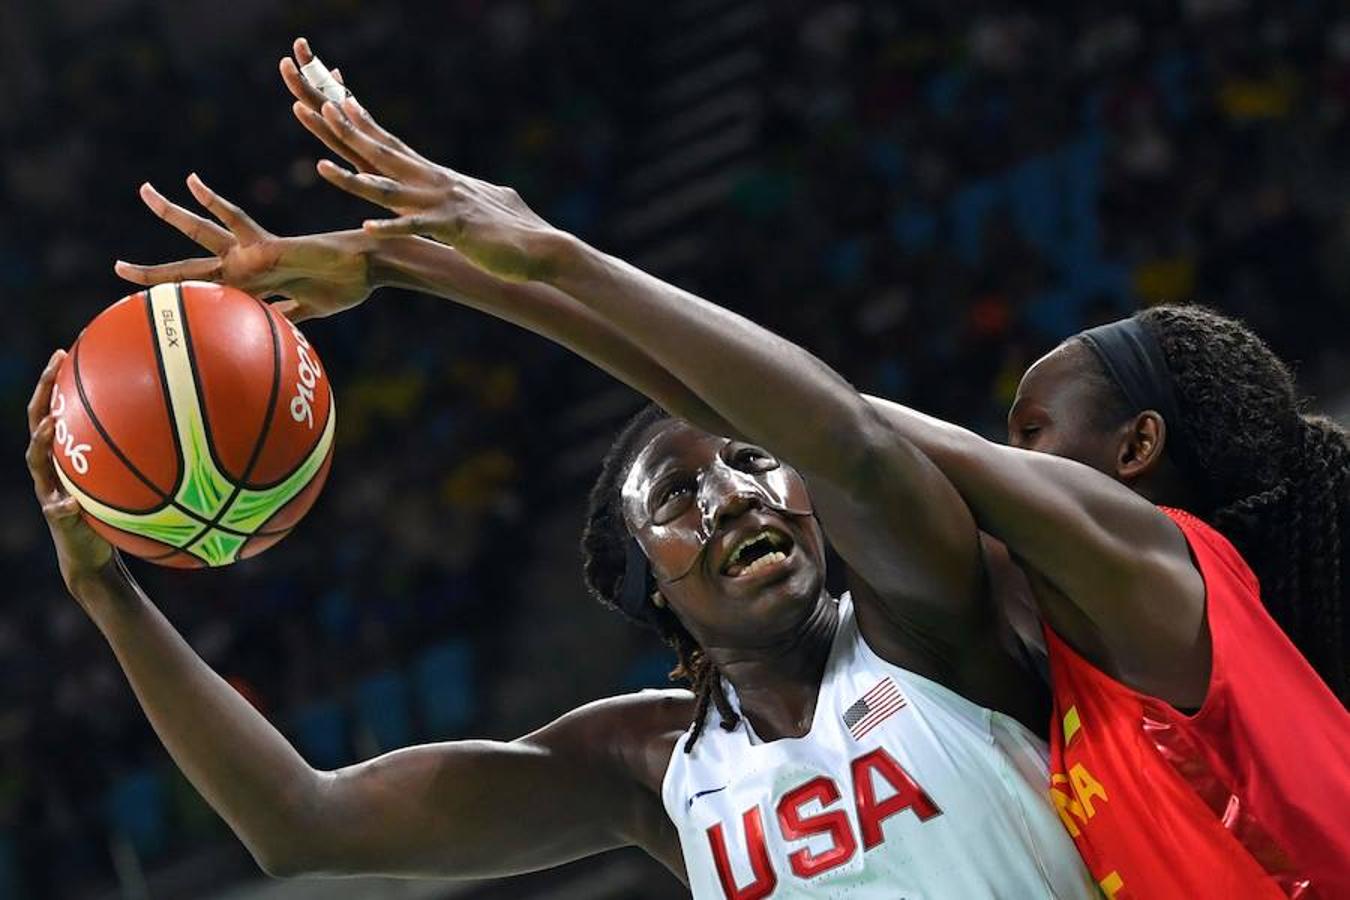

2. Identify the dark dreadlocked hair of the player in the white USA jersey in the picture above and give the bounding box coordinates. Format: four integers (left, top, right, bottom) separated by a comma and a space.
582, 403, 740, 753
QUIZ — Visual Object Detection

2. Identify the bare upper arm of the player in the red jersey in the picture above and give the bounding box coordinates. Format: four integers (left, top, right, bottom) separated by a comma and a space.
880, 401, 1208, 702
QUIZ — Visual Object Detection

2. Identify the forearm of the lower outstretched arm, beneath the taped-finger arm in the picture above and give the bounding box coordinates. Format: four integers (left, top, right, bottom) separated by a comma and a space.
373, 237, 730, 434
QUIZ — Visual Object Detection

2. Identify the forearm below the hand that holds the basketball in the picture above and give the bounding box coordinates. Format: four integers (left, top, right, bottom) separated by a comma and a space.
80, 565, 317, 870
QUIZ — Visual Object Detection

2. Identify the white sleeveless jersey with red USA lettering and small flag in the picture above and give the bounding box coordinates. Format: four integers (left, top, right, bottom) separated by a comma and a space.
662, 594, 1100, 900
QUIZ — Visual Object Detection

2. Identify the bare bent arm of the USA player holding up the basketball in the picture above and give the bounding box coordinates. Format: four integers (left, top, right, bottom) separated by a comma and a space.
27, 352, 689, 877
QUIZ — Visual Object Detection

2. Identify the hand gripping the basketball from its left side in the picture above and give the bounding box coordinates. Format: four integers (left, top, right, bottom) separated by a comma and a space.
26, 349, 113, 598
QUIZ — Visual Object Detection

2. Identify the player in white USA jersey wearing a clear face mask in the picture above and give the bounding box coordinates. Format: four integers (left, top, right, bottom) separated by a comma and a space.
28, 38, 1094, 900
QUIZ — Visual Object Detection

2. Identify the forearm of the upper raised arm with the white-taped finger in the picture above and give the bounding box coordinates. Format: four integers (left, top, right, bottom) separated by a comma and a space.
549, 237, 875, 476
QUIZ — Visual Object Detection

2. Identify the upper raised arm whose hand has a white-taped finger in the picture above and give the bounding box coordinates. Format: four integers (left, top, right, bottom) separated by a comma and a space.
282, 42, 983, 637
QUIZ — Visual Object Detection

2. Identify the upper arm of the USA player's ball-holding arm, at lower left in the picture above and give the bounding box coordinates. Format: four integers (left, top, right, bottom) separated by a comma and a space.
302, 735, 633, 878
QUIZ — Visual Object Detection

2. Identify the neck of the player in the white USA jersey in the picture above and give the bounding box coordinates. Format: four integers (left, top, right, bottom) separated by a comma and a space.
709, 598, 838, 741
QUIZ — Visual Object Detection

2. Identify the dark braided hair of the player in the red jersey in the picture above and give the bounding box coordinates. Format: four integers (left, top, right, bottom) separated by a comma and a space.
1080, 306, 1350, 703
